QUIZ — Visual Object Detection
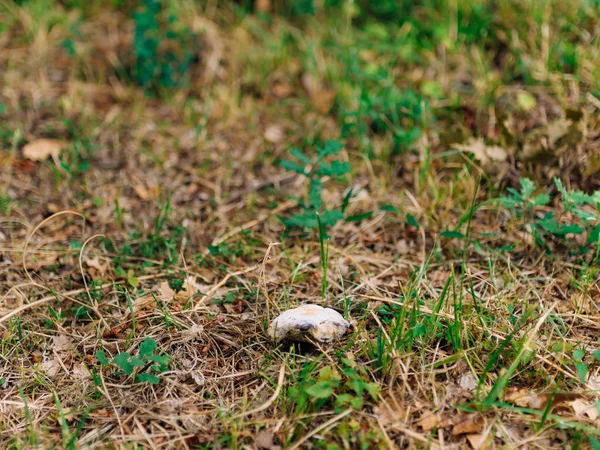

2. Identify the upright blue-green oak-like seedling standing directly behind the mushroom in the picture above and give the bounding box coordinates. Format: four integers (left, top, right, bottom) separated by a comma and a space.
280, 140, 352, 229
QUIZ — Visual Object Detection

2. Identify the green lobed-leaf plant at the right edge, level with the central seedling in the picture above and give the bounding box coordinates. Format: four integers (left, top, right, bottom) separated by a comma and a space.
497, 178, 600, 253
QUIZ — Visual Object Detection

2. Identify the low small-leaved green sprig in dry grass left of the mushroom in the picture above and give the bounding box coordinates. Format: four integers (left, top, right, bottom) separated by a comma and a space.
96, 338, 170, 384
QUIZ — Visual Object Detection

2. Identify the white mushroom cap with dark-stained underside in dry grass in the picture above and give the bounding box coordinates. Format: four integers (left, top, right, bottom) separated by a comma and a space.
269, 305, 350, 344
